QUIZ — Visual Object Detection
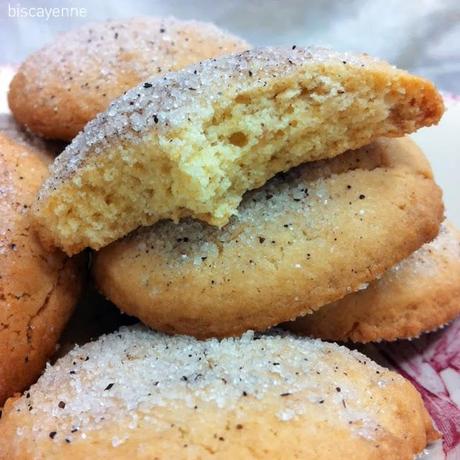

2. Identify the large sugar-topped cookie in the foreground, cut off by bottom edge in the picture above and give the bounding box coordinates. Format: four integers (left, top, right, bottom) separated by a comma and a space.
0, 327, 438, 460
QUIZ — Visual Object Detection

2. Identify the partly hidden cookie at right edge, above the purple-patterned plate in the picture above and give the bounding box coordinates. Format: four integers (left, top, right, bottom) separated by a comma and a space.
286, 223, 460, 343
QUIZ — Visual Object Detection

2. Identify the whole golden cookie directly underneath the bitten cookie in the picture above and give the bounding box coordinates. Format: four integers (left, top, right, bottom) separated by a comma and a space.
93, 138, 443, 337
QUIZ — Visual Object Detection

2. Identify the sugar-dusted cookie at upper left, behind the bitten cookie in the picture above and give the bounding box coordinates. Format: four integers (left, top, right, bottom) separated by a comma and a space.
8, 17, 249, 140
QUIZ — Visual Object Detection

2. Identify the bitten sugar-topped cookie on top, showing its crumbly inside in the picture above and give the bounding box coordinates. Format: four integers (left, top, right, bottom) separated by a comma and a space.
34, 47, 443, 254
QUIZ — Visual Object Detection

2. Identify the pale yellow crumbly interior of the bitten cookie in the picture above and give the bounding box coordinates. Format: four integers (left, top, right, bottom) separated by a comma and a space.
38, 61, 438, 253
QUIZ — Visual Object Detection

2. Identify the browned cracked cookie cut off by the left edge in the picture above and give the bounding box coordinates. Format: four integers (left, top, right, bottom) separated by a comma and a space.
0, 133, 84, 407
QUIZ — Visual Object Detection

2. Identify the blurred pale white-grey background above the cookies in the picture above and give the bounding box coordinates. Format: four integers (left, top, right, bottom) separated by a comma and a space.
0, 0, 460, 94
